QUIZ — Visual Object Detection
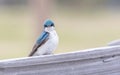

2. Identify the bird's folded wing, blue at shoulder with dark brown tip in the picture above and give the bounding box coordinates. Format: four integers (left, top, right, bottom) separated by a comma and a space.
29, 32, 49, 56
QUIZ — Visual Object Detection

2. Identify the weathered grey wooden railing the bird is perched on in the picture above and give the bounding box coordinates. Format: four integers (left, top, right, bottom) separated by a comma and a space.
0, 40, 120, 75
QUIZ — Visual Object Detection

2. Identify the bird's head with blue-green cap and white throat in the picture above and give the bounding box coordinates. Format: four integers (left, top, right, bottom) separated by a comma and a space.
44, 19, 55, 32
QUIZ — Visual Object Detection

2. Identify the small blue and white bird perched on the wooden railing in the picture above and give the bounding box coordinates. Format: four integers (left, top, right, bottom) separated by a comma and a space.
29, 19, 59, 56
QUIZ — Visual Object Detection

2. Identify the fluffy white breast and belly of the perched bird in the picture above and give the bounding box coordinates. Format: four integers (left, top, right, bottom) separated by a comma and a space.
36, 30, 59, 55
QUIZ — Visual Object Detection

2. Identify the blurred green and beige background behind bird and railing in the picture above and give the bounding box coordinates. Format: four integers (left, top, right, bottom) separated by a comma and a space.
0, 0, 120, 59
